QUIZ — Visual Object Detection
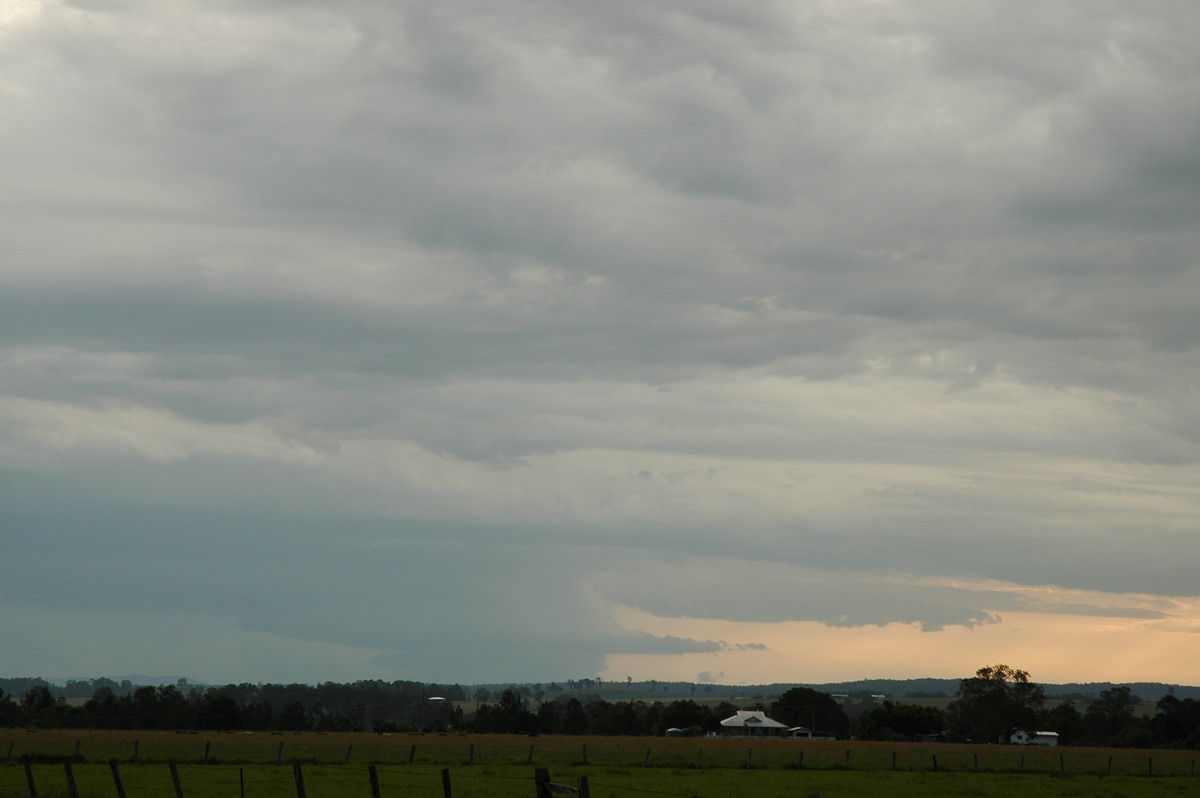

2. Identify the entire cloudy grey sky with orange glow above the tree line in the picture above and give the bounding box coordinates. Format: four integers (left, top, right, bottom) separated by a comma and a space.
0, 0, 1200, 684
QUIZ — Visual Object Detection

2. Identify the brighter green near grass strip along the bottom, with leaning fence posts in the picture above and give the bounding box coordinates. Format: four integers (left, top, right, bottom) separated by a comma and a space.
0, 764, 1196, 798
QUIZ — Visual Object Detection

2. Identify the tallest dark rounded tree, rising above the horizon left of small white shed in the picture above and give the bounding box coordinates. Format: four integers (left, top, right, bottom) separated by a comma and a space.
946, 665, 1045, 743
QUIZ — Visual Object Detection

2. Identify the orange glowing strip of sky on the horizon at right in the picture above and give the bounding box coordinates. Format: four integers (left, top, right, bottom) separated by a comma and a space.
604, 599, 1200, 684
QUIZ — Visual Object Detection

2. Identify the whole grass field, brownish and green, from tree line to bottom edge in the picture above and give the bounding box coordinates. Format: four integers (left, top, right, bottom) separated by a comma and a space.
0, 731, 1200, 798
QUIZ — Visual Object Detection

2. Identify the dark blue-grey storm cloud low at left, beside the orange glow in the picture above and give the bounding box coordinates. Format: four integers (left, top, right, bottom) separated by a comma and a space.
2, 496, 720, 680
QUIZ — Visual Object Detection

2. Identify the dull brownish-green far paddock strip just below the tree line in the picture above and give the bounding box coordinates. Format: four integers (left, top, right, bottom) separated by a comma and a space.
9, 730, 1200, 775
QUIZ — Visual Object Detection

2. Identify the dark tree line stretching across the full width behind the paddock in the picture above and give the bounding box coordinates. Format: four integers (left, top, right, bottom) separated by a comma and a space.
7, 665, 1200, 749
